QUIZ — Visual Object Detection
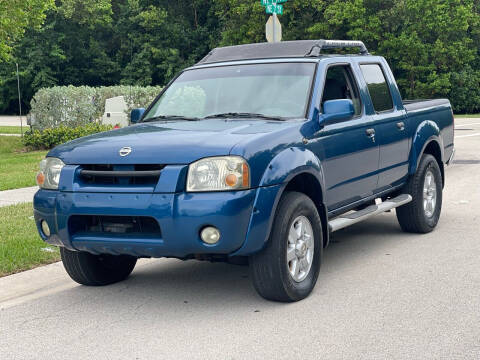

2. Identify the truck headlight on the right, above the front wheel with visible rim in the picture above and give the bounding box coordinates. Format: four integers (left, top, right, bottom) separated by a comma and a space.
187, 156, 250, 192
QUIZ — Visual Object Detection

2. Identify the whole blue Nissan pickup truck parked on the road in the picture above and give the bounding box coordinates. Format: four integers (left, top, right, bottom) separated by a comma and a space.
34, 40, 454, 302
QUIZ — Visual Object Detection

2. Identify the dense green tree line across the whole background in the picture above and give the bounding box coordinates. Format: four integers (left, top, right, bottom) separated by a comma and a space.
0, 0, 480, 113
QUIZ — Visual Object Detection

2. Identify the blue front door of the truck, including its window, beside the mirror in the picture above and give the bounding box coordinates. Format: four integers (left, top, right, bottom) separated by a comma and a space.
312, 63, 379, 211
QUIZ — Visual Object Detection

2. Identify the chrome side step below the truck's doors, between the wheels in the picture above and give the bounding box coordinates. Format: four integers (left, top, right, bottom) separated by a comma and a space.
328, 194, 412, 232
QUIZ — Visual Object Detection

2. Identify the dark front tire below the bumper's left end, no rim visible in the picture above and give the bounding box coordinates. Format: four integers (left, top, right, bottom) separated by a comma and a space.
60, 247, 137, 286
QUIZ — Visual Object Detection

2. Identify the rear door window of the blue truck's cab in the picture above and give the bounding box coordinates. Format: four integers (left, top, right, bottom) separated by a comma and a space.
360, 64, 393, 112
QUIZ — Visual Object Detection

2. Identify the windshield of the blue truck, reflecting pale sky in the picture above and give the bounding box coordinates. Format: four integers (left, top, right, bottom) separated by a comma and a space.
143, 63, 315, 121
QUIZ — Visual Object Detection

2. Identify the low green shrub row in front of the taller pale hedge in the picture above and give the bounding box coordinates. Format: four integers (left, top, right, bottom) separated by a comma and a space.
23, 123, 113, 150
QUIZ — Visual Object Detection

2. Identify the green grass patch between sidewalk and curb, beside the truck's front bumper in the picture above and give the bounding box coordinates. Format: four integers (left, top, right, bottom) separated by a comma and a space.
0, 203, 60, 277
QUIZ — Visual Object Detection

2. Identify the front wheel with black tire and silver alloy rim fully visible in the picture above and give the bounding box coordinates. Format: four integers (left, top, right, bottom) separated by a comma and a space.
249, 192, 323, 302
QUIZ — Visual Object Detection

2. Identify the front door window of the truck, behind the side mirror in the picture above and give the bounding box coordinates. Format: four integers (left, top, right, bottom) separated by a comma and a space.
322, 65, 362, 116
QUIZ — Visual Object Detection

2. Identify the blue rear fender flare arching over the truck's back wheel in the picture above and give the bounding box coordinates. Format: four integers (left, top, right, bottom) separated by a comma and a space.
408, 120, 444, 175
